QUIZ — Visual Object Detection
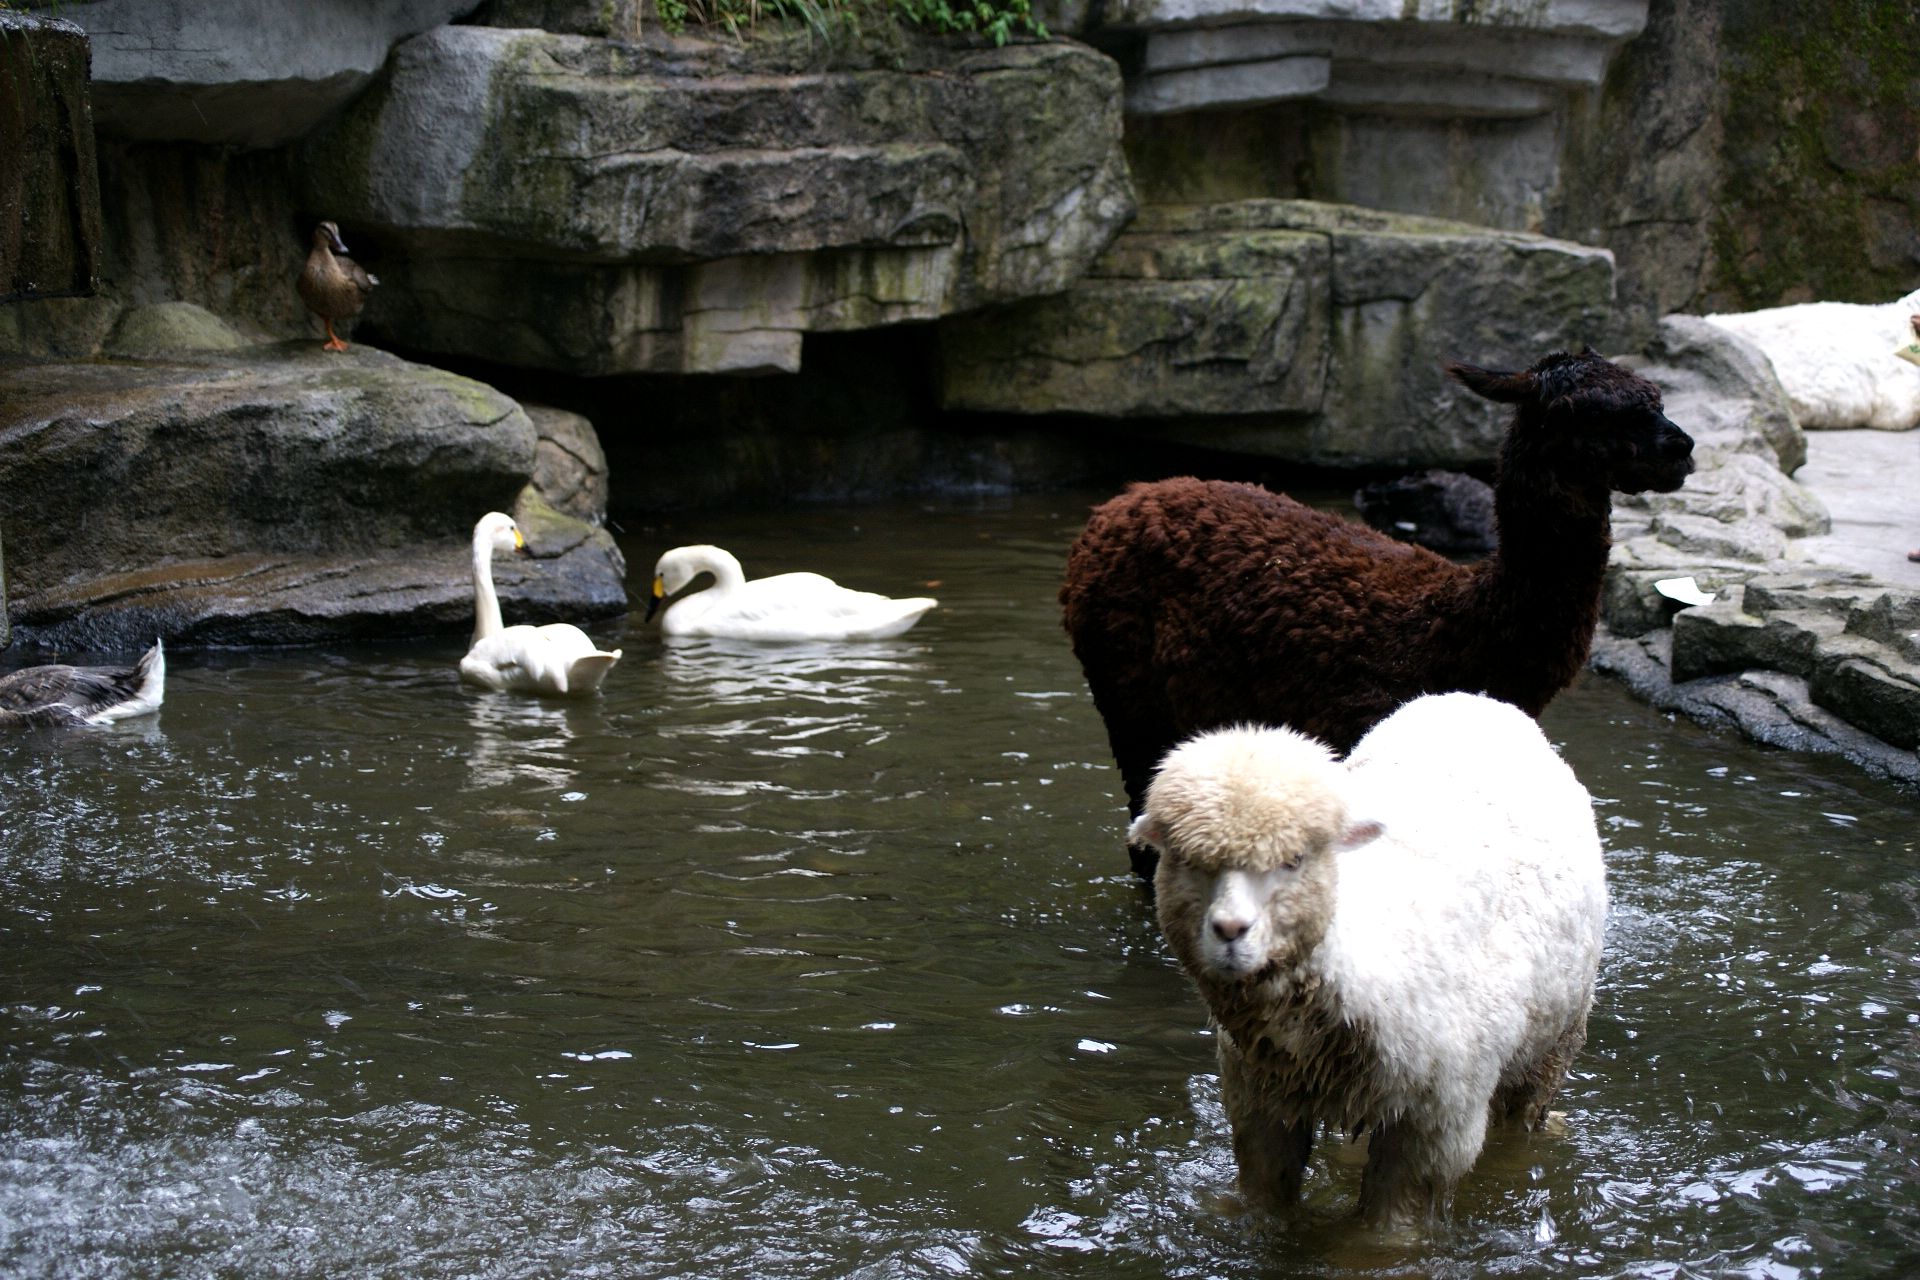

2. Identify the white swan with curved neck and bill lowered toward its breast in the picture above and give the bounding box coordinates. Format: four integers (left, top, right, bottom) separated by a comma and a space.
647, 543, 939, 641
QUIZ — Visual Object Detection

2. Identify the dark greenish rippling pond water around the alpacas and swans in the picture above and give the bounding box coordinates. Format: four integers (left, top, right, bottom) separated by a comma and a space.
0, 493, 1920, 1278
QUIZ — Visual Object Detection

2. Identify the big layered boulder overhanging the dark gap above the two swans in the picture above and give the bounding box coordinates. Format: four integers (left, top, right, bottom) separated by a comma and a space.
300, 27, 1133, 374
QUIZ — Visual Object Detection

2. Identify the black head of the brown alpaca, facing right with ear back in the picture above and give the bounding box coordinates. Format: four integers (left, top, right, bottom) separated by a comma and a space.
1448, 347, 1693, 493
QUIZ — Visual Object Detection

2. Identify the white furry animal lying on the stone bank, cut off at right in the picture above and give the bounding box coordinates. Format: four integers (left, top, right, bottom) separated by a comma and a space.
1705, 290, 1920, 432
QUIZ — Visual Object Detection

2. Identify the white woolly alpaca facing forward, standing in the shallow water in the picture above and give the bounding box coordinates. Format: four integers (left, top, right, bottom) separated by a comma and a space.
1129, 693, 1607, 1226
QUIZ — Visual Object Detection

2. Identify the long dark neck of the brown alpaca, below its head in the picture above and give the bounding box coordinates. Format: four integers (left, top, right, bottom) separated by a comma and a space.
1465, 470, 1613, 714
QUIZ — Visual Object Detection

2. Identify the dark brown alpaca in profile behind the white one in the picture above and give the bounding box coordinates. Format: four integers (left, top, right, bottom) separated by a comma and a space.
1060, 349, 1693, 877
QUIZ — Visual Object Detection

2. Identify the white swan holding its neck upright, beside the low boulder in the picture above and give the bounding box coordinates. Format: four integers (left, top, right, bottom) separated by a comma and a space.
461, 510, 620, 695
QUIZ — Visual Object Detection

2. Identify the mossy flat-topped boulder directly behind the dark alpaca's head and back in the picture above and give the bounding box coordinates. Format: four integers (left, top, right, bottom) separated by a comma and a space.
941, 200, 1613, 468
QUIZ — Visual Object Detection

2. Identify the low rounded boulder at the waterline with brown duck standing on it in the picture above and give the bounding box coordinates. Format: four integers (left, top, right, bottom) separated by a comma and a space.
0, 344, 626, 649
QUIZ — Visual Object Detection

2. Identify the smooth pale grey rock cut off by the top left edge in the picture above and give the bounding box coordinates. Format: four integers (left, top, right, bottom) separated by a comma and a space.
60, 0, 478, 148
